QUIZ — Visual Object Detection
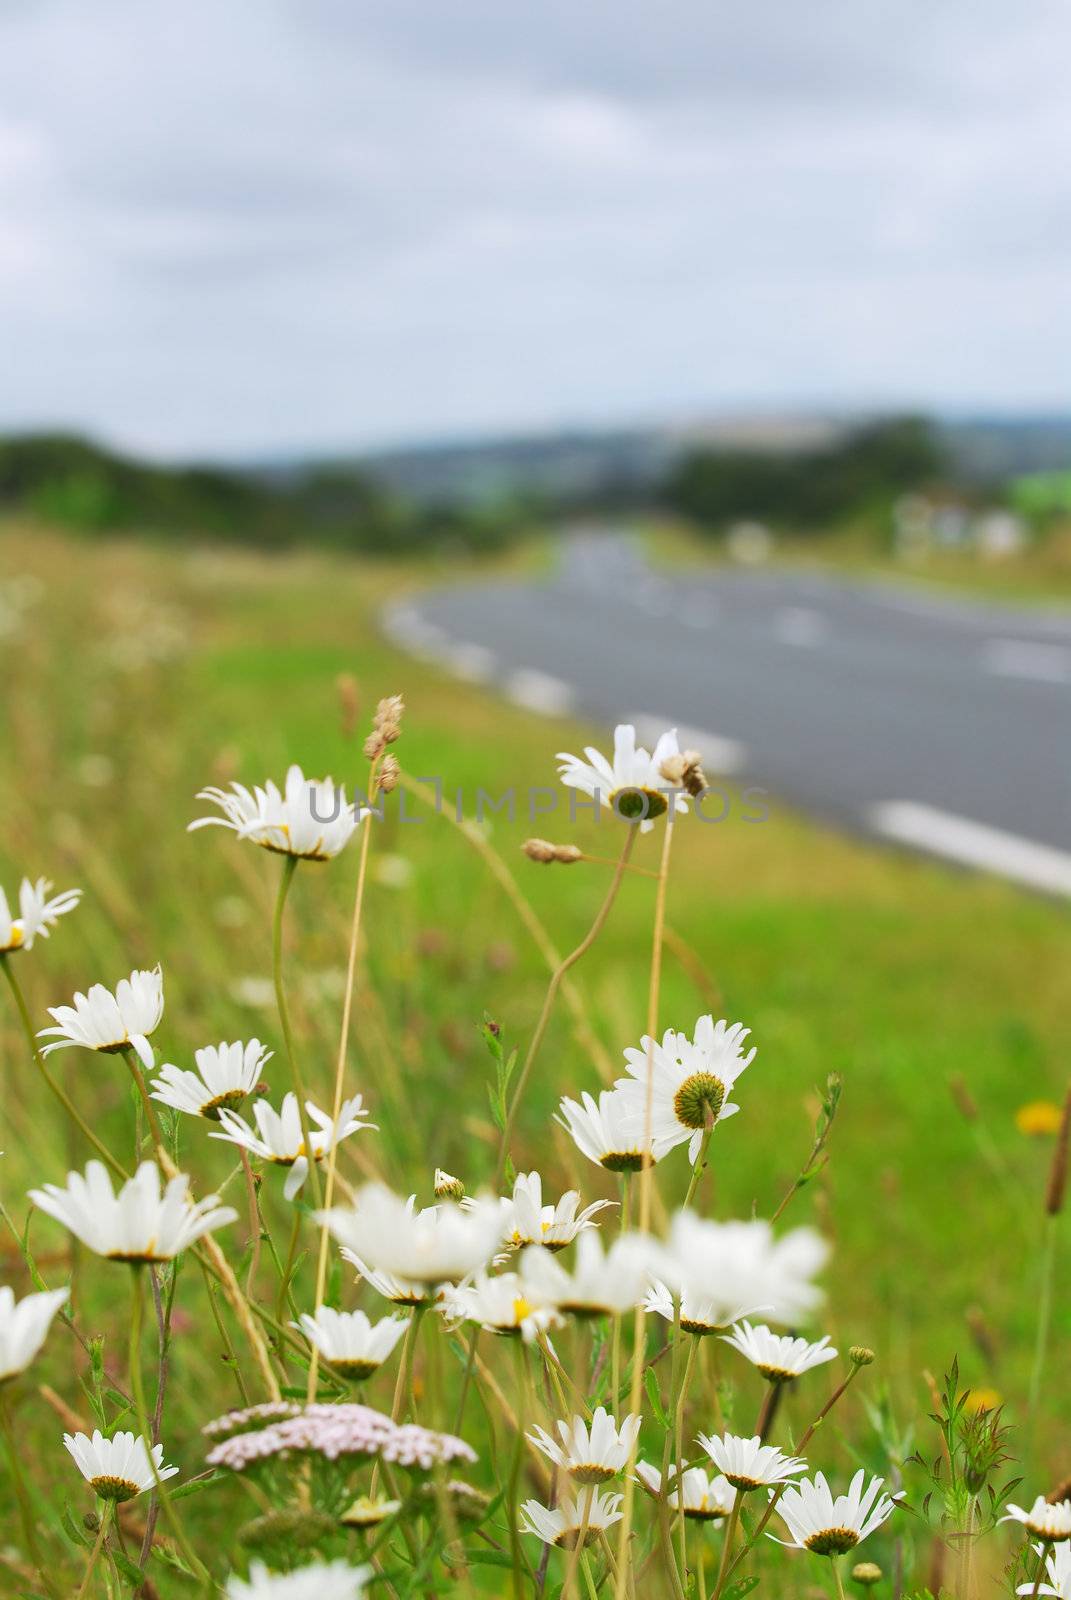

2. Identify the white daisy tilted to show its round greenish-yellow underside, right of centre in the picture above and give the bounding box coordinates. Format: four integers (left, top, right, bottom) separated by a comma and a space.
616, 1016, 756, 1162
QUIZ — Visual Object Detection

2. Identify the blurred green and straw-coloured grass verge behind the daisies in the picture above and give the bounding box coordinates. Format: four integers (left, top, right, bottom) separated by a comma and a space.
0, 526, 1071, 1594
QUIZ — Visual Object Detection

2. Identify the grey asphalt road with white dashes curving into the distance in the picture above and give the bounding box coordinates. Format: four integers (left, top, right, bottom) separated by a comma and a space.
386, 531, 1071, 896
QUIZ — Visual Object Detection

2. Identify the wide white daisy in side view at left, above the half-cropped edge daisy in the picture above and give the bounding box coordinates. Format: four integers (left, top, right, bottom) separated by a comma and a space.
30, 1162, 239, 1262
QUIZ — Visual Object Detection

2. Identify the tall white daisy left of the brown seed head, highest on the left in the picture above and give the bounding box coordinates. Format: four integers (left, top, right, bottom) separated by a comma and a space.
189, 766, 367, 861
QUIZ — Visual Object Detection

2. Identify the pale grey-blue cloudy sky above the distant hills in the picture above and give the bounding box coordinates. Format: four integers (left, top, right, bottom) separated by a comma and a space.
0, 0, 1071, 456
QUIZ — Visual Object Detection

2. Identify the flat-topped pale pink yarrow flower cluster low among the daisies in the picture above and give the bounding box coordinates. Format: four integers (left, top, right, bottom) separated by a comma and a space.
205, 1402, 475, 1472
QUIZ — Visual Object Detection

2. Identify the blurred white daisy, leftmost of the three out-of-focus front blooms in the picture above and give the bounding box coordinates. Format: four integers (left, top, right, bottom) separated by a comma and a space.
317, 1184, 503, 1293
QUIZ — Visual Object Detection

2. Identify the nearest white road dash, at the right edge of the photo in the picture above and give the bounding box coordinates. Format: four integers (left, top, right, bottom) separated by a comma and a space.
868, 800, 1071, 896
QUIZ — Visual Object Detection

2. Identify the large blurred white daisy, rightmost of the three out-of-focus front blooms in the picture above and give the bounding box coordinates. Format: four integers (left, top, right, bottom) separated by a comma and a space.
669, 1211, 829, 1331
